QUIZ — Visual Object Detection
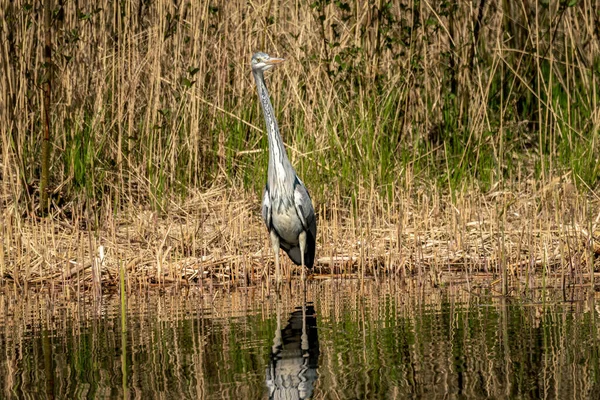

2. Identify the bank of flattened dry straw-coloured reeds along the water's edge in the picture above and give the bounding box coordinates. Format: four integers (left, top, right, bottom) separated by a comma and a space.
0, 177, 600, 290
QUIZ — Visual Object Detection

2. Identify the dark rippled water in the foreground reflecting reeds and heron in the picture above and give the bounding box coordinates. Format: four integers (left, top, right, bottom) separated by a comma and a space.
0, 281, 600, 399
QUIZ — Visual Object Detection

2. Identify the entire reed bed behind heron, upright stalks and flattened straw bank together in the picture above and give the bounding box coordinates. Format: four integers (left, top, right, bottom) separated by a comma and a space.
0, 0, 600, 293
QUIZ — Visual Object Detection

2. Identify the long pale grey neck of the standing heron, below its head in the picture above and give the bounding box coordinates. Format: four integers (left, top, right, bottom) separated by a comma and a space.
252, 71, 294, 187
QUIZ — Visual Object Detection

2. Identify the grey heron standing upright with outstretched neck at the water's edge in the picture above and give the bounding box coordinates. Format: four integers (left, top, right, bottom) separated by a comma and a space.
252, 52, 317, 285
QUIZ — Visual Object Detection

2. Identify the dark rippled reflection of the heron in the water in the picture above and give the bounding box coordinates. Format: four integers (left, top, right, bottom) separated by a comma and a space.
266, 303, 319, 399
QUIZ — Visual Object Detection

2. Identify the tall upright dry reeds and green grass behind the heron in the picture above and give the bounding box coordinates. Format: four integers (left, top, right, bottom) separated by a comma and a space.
0, 0, 600, 288
